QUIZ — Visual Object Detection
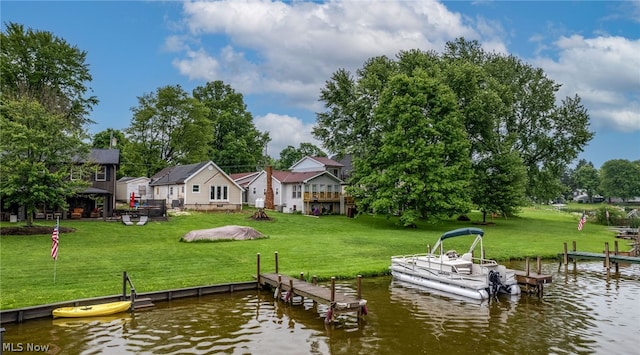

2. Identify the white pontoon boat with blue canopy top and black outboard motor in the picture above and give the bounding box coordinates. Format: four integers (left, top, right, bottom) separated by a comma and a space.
390, 228, 520, 300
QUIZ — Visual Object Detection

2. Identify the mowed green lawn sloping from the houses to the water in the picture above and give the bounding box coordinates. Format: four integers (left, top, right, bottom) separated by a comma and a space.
0, 207, 614, 309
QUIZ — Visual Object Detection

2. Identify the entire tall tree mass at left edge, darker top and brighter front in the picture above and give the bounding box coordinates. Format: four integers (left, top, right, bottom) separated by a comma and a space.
0, 23, 98, 225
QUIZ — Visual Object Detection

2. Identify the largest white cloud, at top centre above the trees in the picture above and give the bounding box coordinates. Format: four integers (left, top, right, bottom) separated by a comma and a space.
174, 0, 480, 110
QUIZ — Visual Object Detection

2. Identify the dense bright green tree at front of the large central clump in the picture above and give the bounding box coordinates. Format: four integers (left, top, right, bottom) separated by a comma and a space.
348, 73, 470, 226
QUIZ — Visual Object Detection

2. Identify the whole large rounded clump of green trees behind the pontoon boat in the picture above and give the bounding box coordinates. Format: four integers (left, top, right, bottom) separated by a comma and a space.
313, 38, 593, 223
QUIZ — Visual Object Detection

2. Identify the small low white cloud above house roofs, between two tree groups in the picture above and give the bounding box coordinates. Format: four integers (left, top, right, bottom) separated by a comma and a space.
254, 113, 322, 158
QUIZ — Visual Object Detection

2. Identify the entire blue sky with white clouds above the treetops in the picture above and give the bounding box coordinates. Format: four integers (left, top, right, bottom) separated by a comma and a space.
0, 0, 640, 167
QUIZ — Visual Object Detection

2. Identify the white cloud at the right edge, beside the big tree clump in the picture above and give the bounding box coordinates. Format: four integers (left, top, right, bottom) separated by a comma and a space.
534, 35, 640, 132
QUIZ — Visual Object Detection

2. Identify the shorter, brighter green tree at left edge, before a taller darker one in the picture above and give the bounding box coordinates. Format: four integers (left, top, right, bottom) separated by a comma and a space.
0, 99, 90, 226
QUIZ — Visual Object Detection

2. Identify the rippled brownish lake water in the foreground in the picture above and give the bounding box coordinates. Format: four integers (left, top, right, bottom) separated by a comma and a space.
4, 262, 640, 354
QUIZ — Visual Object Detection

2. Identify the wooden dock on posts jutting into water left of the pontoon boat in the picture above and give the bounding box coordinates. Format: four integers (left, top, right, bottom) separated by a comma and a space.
257, 252, 367, 323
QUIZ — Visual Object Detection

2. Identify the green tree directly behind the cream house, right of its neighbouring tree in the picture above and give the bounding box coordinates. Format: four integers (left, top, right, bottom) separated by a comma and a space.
193, 80, 269, 173
